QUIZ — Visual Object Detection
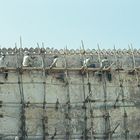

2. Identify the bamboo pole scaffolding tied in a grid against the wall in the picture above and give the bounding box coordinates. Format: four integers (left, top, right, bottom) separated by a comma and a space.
0, 47, 140, 140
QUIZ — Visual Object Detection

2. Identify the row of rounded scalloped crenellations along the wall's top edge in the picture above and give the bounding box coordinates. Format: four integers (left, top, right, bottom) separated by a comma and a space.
0, 47, 140, 55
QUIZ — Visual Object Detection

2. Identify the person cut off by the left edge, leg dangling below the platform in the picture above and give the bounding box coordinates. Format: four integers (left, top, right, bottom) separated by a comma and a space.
0, 54, 8, 80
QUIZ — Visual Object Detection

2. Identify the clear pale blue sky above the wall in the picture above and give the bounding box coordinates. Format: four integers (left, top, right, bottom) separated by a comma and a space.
0, 0, 140, 49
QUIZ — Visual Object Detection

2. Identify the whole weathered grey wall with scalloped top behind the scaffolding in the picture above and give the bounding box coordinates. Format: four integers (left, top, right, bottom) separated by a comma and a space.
0, 48, 140, 140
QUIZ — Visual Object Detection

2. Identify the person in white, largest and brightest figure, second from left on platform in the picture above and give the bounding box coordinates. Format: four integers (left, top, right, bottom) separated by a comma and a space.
22, 52, 33, 67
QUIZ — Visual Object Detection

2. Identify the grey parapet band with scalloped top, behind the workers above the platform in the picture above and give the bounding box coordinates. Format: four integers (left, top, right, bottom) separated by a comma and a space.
0, 47, 140, 69
